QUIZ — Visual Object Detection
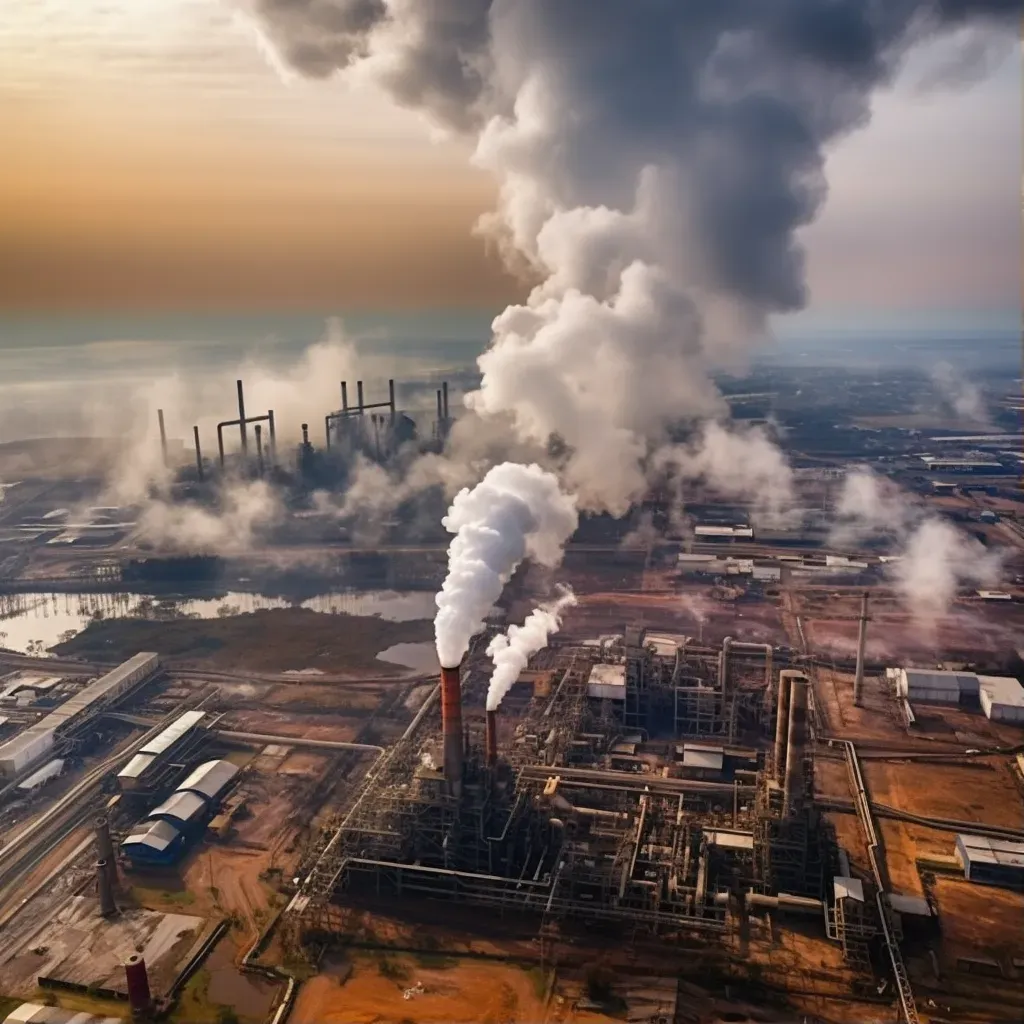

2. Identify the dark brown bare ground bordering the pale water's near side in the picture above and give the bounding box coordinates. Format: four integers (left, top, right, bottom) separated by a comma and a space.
53, 608, 433, 676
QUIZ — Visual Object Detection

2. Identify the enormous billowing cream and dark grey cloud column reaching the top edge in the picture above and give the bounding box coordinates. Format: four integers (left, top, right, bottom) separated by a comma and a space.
238, 0, 1021, 513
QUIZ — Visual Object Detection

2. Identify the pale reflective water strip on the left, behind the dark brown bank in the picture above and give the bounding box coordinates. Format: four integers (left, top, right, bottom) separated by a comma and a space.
0, 591, 437, 651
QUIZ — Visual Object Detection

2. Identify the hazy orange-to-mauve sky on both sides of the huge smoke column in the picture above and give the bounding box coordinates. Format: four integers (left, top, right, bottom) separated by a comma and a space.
0, 0, 1022, 319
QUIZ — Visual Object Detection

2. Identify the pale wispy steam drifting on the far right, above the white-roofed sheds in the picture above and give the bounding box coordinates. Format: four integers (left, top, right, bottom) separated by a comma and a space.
833, 468, 1001, 628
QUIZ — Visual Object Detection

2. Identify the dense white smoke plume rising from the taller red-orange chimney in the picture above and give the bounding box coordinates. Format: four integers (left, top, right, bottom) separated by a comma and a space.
434, 463, 579, 668
